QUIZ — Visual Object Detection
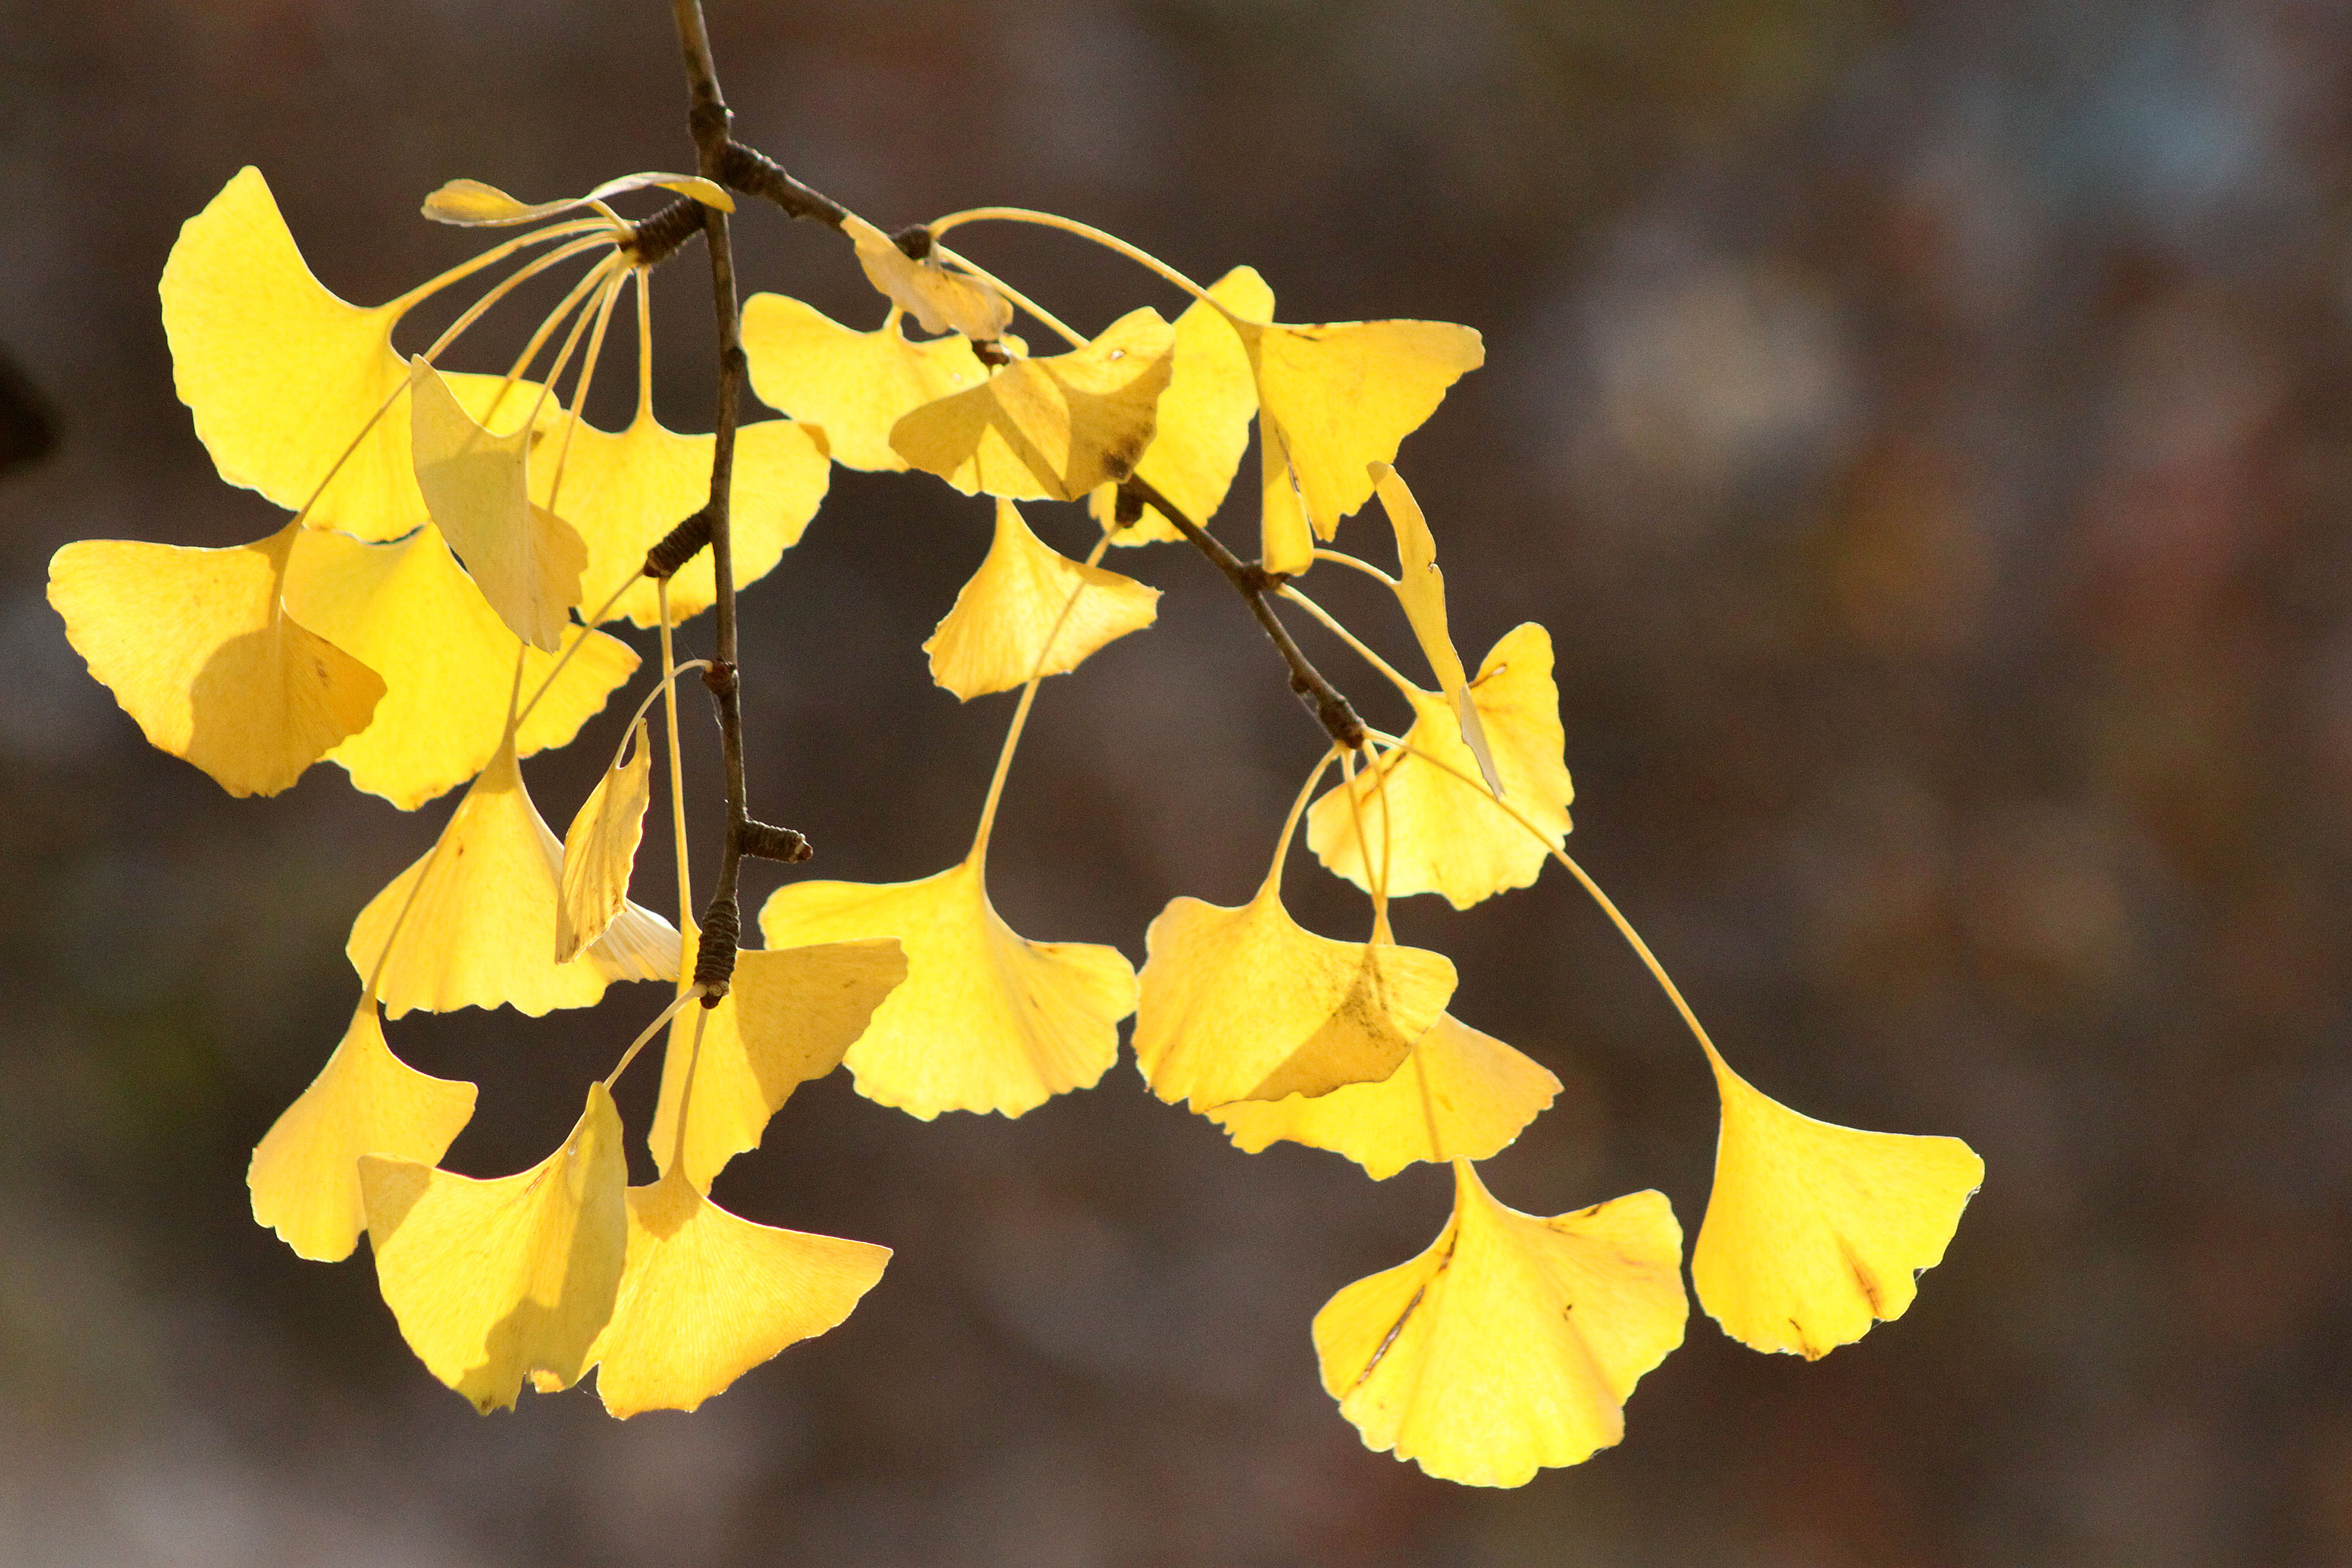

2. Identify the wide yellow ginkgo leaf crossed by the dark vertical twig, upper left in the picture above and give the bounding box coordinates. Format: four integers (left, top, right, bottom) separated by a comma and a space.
532, 402, 833, 626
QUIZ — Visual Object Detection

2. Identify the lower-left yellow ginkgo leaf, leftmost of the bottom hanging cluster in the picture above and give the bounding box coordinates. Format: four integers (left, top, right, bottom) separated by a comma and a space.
245, 997, 473, 1262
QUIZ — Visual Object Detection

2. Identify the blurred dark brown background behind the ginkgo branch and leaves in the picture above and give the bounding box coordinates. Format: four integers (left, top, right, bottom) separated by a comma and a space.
0, 0, 2352, 1568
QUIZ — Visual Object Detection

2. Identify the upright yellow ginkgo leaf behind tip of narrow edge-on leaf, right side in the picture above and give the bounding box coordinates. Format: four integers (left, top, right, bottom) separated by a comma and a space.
1308, 621, 1576, 910
